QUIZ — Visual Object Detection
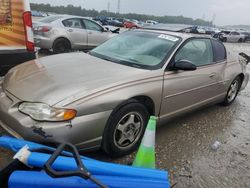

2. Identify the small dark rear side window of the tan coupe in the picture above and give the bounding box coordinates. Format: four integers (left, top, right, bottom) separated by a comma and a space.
212, 40, 227, 62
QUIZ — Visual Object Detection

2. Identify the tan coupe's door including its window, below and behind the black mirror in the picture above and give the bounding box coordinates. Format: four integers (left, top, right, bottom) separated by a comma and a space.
161, 38, 220, 118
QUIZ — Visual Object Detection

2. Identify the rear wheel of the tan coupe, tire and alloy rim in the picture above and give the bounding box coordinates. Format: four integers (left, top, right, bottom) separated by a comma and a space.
222, 77, 242, 106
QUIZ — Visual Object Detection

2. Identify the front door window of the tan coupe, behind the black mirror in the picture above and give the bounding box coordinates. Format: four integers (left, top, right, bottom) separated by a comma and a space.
175, 39, 213, 67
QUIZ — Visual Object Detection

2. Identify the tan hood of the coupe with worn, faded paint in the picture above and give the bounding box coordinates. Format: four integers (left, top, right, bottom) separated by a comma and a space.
3, 53, 151, 105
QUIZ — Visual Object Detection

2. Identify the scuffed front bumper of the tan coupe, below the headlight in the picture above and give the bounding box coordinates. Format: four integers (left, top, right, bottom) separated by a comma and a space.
0, 87, 111, 150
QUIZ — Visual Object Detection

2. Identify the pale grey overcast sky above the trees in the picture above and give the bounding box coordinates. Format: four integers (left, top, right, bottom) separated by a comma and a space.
30, 0, 250, 25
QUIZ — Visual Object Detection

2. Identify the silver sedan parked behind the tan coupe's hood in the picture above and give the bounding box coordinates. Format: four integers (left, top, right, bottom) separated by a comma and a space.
34, 15, 115, 53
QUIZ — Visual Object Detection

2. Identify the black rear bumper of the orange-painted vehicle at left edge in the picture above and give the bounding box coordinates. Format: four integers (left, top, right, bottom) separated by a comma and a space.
0, 49, 36, 76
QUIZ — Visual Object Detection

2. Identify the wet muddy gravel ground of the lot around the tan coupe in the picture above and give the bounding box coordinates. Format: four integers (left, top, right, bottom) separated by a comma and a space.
0, 43, 250, 188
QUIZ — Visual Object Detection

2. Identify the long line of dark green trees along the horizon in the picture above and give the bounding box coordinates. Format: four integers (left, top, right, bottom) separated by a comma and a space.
31, 3, 212, 26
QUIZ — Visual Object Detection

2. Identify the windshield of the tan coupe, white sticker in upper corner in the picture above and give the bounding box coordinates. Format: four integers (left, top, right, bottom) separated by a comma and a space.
90, 31, 180, 69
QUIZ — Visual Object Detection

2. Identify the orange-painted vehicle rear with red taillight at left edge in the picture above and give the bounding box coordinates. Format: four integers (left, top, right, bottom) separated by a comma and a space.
0, 0, 36, 76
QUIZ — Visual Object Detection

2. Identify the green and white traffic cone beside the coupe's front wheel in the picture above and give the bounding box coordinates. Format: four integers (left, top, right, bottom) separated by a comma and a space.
133, 116, 156, 169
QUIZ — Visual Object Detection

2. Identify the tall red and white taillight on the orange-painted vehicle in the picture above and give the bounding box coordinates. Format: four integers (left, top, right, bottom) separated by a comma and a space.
23, 11, 35, 52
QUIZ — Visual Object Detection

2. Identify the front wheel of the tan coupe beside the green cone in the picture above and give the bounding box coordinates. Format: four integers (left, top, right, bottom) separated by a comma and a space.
102, 101, 149, 157
